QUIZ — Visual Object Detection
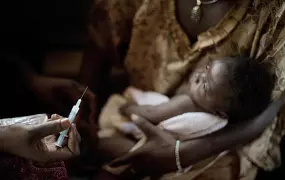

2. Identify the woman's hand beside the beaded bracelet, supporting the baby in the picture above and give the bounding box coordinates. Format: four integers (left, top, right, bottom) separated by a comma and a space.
110, 115, 176, 175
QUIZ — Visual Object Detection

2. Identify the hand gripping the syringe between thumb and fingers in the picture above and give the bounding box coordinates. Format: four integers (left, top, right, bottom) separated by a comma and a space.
0, 115, 80, 162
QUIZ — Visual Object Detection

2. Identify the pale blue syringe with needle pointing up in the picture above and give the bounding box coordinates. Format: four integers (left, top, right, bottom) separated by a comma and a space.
56, 87, 88, 147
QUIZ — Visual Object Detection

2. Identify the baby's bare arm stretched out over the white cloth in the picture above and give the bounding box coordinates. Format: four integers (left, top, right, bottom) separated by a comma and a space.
121, 95, 201, 124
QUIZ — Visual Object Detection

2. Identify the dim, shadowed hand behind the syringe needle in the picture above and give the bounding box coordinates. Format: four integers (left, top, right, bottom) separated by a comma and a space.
29, 75, 96, 122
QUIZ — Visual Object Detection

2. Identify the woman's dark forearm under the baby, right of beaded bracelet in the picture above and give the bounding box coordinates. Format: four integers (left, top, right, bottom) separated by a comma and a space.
181, 95, 284, 167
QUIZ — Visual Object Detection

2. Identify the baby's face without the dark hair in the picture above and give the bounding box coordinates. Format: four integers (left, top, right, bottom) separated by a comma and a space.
189, 59, 231, 113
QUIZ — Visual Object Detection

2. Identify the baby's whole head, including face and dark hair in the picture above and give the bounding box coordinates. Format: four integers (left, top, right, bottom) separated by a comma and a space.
189, 57, 273, 121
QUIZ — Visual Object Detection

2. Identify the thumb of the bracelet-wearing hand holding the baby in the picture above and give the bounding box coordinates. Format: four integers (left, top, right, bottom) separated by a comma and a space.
131, 114, 158, 137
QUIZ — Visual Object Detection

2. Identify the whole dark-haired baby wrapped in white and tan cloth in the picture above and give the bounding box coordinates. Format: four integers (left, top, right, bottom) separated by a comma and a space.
99, 57, 273, 174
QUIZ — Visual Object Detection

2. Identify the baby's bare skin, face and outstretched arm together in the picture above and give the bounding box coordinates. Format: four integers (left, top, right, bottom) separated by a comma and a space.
121, 60, 230, 124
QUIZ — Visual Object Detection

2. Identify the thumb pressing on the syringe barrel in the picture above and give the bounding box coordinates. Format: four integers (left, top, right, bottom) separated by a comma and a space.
29, 118, 70, 139
